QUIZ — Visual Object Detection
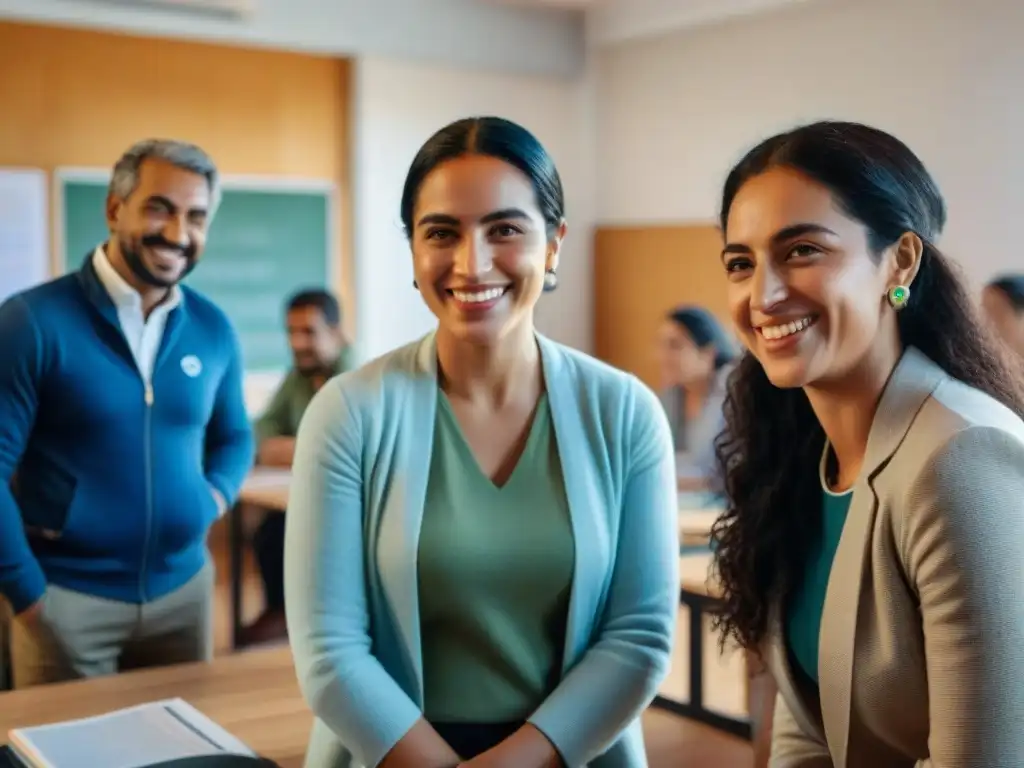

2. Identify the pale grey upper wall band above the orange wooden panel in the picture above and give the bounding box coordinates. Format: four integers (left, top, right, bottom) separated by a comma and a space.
0, 0, 585, 75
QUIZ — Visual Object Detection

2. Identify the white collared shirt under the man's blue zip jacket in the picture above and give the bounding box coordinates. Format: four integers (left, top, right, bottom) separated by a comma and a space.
92, 246, 181, 386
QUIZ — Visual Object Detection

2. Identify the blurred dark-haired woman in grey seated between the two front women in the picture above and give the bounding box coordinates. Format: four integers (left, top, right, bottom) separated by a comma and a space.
657, 306, 736, 493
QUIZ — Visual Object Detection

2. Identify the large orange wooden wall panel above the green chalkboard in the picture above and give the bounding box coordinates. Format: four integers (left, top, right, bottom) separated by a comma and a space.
0, 23, 355, 331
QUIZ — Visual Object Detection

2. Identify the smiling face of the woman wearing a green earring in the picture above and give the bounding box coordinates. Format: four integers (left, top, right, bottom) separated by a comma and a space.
722, 168, 921, 388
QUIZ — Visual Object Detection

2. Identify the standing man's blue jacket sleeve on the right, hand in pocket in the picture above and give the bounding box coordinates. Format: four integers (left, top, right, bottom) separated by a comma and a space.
205, 326, 255, 506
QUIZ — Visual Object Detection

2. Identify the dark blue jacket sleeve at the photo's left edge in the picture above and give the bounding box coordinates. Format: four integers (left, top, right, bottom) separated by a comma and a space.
0, 297, 46, 613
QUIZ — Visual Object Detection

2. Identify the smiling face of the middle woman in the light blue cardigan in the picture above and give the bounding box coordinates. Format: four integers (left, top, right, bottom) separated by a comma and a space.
412, 155, 565, 344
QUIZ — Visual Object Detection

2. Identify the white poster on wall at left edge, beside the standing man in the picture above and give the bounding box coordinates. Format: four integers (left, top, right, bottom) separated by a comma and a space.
0, 168, 50, 302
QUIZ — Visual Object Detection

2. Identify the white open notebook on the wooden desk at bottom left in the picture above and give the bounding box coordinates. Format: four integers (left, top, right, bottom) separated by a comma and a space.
6, 698, 268, 768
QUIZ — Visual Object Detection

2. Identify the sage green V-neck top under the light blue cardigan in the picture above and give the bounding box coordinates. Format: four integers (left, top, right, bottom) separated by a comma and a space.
418, 393, 575, 723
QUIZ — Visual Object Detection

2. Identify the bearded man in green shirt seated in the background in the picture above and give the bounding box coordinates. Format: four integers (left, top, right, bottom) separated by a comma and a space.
242, 290, 351, 644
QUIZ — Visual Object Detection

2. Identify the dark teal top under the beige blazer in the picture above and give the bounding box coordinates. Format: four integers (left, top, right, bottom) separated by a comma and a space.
785, 444, 853, 685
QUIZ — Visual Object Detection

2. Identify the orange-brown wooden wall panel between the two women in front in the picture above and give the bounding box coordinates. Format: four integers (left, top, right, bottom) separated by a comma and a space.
594, 224, 728, 387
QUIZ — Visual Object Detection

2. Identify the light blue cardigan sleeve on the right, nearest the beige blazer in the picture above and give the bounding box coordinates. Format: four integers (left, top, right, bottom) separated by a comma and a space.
529, 381, 679, 766
